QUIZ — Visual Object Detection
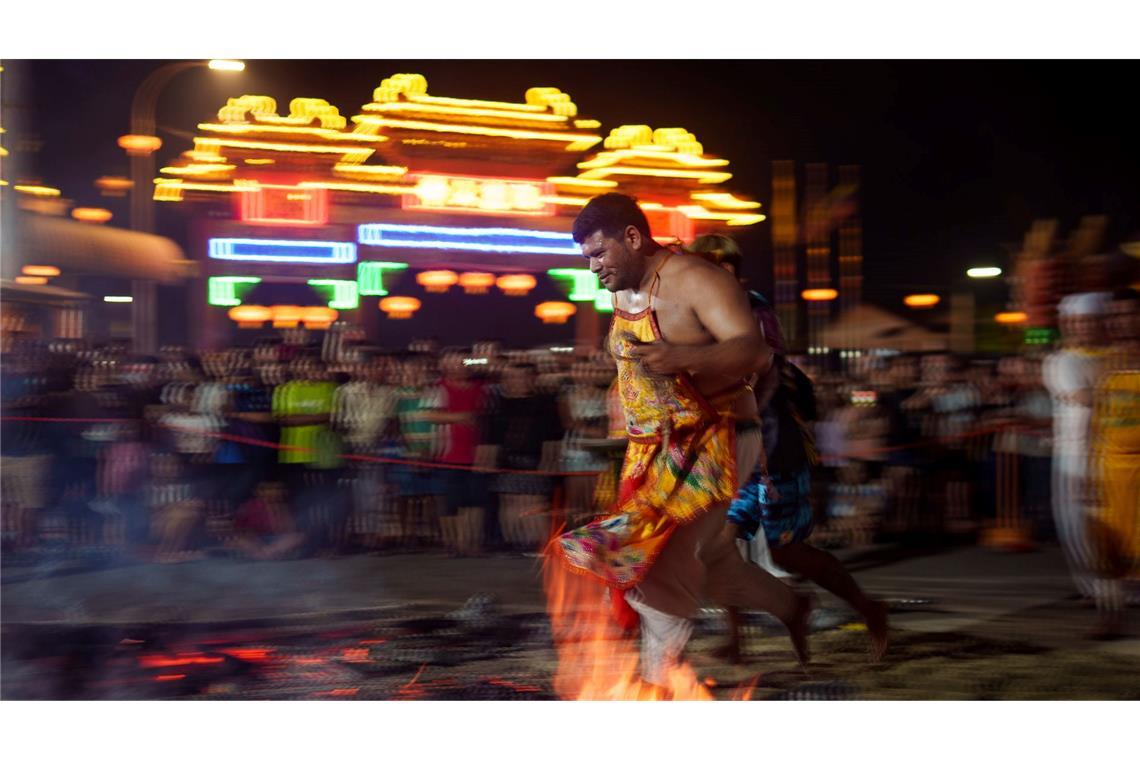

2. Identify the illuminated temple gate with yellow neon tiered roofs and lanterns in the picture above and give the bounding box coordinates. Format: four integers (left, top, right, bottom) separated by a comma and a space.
155, 74, 764, 348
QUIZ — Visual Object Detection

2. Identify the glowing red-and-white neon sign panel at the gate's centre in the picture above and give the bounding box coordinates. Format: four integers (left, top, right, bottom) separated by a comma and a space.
400, 172, 555, 216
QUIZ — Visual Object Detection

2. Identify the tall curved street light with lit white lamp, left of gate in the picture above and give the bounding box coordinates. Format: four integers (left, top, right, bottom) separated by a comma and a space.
120, 60, 245, 353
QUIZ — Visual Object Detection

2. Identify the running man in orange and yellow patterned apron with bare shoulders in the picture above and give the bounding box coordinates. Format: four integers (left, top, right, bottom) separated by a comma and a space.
557, 194, 811, 686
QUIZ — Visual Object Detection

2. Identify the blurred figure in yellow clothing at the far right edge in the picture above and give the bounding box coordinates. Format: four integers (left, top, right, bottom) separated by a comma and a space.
1090, 291, 1140, 639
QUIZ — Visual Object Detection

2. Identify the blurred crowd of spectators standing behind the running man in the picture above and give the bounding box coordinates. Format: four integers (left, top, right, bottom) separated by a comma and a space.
0, 287, 1140, 576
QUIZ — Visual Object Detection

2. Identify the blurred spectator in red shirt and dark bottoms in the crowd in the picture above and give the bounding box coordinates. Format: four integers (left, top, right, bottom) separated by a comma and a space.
430, 352, 486, 556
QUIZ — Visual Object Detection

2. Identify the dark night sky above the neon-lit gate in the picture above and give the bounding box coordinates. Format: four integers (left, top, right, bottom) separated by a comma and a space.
3, 60, 1140, 304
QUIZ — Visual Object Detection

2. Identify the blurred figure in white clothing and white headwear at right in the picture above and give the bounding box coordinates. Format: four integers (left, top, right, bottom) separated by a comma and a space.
1042, 293, 1108, 599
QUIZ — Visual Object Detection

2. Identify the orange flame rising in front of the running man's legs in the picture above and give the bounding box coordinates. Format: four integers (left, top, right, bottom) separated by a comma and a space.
543, 541, 713, 702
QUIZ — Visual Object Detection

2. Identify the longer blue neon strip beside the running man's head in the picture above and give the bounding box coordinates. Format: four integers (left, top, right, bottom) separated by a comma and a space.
357, 224, 581, 256
